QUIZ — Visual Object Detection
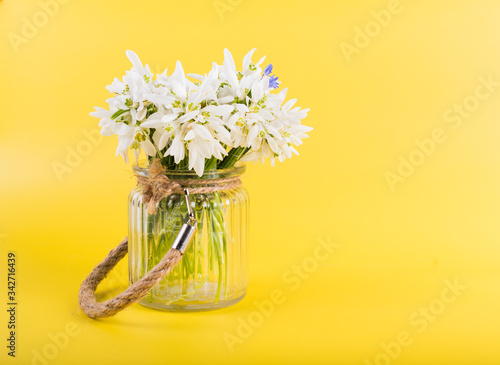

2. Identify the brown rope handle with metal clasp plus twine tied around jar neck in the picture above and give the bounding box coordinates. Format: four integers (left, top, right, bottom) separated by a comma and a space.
78, 159, 241, 319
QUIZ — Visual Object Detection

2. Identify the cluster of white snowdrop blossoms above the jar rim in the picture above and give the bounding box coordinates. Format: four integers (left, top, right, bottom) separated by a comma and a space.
90, 49, 312, 176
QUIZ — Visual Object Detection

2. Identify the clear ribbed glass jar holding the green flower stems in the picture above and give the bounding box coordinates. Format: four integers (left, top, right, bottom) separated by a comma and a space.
128, 166, 249, 311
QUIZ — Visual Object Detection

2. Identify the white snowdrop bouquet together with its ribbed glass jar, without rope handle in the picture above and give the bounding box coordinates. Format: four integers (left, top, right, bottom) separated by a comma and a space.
91, 49, 312, 310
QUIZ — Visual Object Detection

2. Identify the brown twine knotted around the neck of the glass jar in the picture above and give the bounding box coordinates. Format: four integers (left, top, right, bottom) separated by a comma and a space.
136, 159, 241, 214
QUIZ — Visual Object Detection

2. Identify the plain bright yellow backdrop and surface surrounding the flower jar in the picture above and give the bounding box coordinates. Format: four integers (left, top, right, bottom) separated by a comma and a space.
0, 0, 500, 365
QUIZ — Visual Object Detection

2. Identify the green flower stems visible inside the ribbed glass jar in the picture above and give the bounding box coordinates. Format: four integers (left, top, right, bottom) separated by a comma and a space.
145, 188, 229, 304
